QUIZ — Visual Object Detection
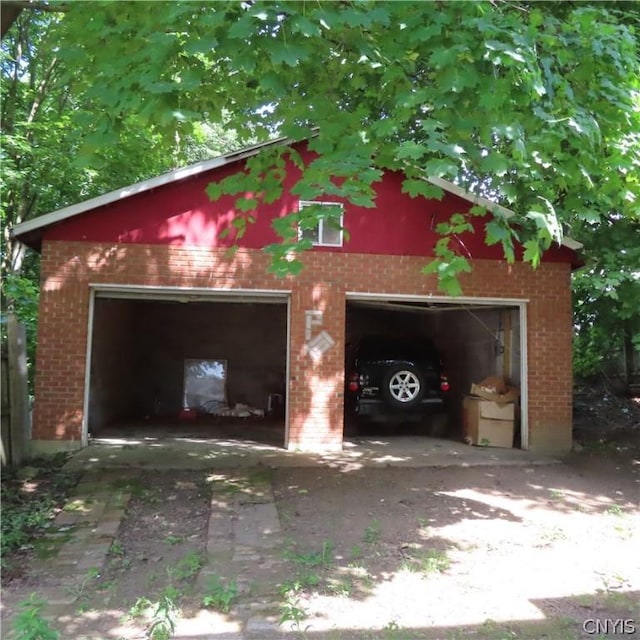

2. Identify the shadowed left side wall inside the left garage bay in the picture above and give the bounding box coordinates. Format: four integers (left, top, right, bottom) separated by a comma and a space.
89, 298, 137, 432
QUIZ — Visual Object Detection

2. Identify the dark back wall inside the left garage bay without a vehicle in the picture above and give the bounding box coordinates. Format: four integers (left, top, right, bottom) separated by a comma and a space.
135, 301, 287, 416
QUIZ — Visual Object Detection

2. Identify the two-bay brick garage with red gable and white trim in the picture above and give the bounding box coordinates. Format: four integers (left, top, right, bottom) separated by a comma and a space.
13, 143, 579, 453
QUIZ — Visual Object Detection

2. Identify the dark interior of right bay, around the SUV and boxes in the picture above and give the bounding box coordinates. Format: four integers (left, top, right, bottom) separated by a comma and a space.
345, 299, 521, 448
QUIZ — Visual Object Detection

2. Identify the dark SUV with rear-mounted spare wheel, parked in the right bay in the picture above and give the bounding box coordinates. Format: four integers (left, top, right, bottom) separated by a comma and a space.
346, 336, 449, 435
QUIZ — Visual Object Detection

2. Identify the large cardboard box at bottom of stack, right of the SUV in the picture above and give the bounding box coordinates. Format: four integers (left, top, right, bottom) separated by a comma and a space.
462, 396, 515, 448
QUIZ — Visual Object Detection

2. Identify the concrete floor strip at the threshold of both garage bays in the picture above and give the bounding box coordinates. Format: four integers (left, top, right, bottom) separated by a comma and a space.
65, 430, 559, 471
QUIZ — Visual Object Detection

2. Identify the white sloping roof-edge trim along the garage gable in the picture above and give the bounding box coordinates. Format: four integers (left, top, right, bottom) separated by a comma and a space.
11, 138, 582, 251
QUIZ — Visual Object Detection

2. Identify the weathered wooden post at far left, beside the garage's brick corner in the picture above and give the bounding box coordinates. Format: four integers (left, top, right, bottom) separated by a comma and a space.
7, 313, 30, 466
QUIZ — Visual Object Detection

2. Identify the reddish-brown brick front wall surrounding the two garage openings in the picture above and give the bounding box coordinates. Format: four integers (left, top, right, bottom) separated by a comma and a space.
33, 241, 572, 451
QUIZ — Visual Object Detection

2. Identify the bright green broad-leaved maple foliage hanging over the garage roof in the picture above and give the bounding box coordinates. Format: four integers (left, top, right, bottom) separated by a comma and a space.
55, 0, 640, 290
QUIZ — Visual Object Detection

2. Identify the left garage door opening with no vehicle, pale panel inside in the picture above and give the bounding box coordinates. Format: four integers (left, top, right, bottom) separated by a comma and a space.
86, 291, 288, 446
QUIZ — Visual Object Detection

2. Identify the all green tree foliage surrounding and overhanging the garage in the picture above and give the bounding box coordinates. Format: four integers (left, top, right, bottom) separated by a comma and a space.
0, 0, 640, 384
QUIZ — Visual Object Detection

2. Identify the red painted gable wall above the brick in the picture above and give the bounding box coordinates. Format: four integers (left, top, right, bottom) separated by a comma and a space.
44, 151, 574, 262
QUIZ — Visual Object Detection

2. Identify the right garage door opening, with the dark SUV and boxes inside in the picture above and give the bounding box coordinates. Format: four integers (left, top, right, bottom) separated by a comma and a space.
345, 294, 528, 448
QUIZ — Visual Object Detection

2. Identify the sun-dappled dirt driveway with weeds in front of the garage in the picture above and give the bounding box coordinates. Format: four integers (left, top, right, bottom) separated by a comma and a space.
2, 440, 640, 640
